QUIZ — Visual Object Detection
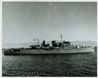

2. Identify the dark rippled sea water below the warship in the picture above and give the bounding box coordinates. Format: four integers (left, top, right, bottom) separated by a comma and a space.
2, 48, 97, 77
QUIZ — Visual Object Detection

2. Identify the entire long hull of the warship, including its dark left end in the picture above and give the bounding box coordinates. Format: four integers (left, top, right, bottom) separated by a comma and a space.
4, 47, 94, 55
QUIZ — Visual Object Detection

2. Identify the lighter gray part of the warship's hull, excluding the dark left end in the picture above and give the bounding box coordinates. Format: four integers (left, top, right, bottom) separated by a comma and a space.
20, 47, 94, 54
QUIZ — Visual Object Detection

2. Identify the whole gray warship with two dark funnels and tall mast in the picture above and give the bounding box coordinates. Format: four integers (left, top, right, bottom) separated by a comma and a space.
4, 35, 94, 55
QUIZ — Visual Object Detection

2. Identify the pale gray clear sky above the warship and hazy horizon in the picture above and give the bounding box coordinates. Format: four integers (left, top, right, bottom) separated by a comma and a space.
2, 2, 97, 43
